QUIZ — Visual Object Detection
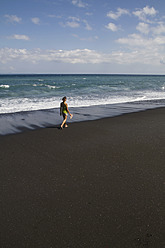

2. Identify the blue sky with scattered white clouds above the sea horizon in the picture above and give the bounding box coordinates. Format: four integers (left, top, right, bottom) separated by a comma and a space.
0, 0, 165, 74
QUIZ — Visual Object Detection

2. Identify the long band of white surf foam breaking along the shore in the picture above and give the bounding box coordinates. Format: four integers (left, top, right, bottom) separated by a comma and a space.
0, 90, 165, 113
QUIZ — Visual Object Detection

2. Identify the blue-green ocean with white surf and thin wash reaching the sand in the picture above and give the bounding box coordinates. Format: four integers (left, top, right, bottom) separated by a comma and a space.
0, 74, 165, 135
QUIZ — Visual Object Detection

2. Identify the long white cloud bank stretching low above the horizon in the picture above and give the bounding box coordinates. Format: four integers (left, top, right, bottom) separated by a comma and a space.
0, 44, 165, 65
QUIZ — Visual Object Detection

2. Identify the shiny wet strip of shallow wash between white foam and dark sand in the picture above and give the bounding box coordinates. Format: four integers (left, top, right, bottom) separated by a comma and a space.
0, 100, 165, 136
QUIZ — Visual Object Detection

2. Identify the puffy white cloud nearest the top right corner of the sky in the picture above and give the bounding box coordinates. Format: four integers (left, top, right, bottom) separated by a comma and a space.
133, 6, 158, 21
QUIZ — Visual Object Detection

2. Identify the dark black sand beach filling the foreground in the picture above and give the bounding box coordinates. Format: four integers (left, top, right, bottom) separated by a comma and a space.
0, 108, 165, 248
